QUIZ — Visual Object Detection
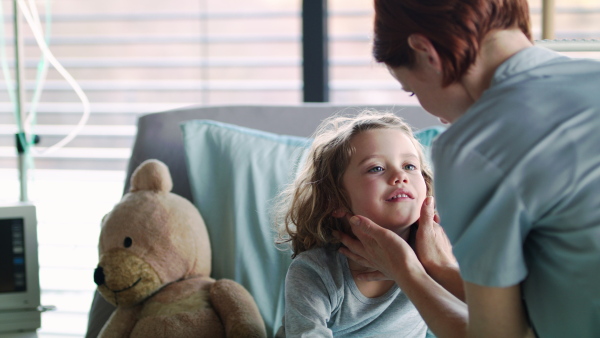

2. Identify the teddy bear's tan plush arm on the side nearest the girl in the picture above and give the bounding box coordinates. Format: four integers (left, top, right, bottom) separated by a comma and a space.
210, 279, 267, 337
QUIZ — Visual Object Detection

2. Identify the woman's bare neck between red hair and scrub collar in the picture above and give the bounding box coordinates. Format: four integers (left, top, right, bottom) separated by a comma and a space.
461, 28, 533, 101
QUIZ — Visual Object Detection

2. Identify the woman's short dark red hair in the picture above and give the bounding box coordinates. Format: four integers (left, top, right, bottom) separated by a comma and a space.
373, 0, 532, 85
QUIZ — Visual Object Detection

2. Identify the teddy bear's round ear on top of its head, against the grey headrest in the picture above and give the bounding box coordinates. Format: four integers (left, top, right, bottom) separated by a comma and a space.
129, 160, 173, 192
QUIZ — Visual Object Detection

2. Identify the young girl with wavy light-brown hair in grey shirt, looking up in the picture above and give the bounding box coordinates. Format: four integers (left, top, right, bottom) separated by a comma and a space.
277, 111, 432, 337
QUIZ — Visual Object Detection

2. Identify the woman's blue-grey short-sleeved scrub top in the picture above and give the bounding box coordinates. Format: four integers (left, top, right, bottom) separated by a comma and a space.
432, 47, 600, 337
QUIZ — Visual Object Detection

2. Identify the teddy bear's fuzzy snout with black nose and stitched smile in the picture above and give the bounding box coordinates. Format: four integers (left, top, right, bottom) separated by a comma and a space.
94, 250, 163, 307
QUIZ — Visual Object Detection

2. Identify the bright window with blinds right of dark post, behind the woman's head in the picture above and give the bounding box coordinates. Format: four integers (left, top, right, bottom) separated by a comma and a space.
329, 0, 600, 104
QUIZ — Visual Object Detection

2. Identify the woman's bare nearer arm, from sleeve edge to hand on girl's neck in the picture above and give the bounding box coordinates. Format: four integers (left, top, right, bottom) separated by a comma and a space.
339, 216, 533, 338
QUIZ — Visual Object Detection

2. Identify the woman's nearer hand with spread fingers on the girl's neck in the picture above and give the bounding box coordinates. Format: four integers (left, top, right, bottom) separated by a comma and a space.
336, 216, 425, 288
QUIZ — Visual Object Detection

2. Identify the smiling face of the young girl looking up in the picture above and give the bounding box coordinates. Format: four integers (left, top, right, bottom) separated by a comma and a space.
338, 129, 427, 235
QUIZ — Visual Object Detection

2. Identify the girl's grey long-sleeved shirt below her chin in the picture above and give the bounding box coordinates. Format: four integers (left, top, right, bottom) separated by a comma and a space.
277, 248, 427, 338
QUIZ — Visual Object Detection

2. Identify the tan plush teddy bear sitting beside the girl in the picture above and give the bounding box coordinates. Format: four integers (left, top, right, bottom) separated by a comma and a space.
94, 159, 266, 338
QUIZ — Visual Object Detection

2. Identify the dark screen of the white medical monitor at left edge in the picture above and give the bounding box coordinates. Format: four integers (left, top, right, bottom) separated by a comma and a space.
0, 218, 27, 293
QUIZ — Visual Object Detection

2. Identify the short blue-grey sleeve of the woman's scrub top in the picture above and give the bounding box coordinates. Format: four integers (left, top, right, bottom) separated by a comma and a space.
434, 146, 530, 287
